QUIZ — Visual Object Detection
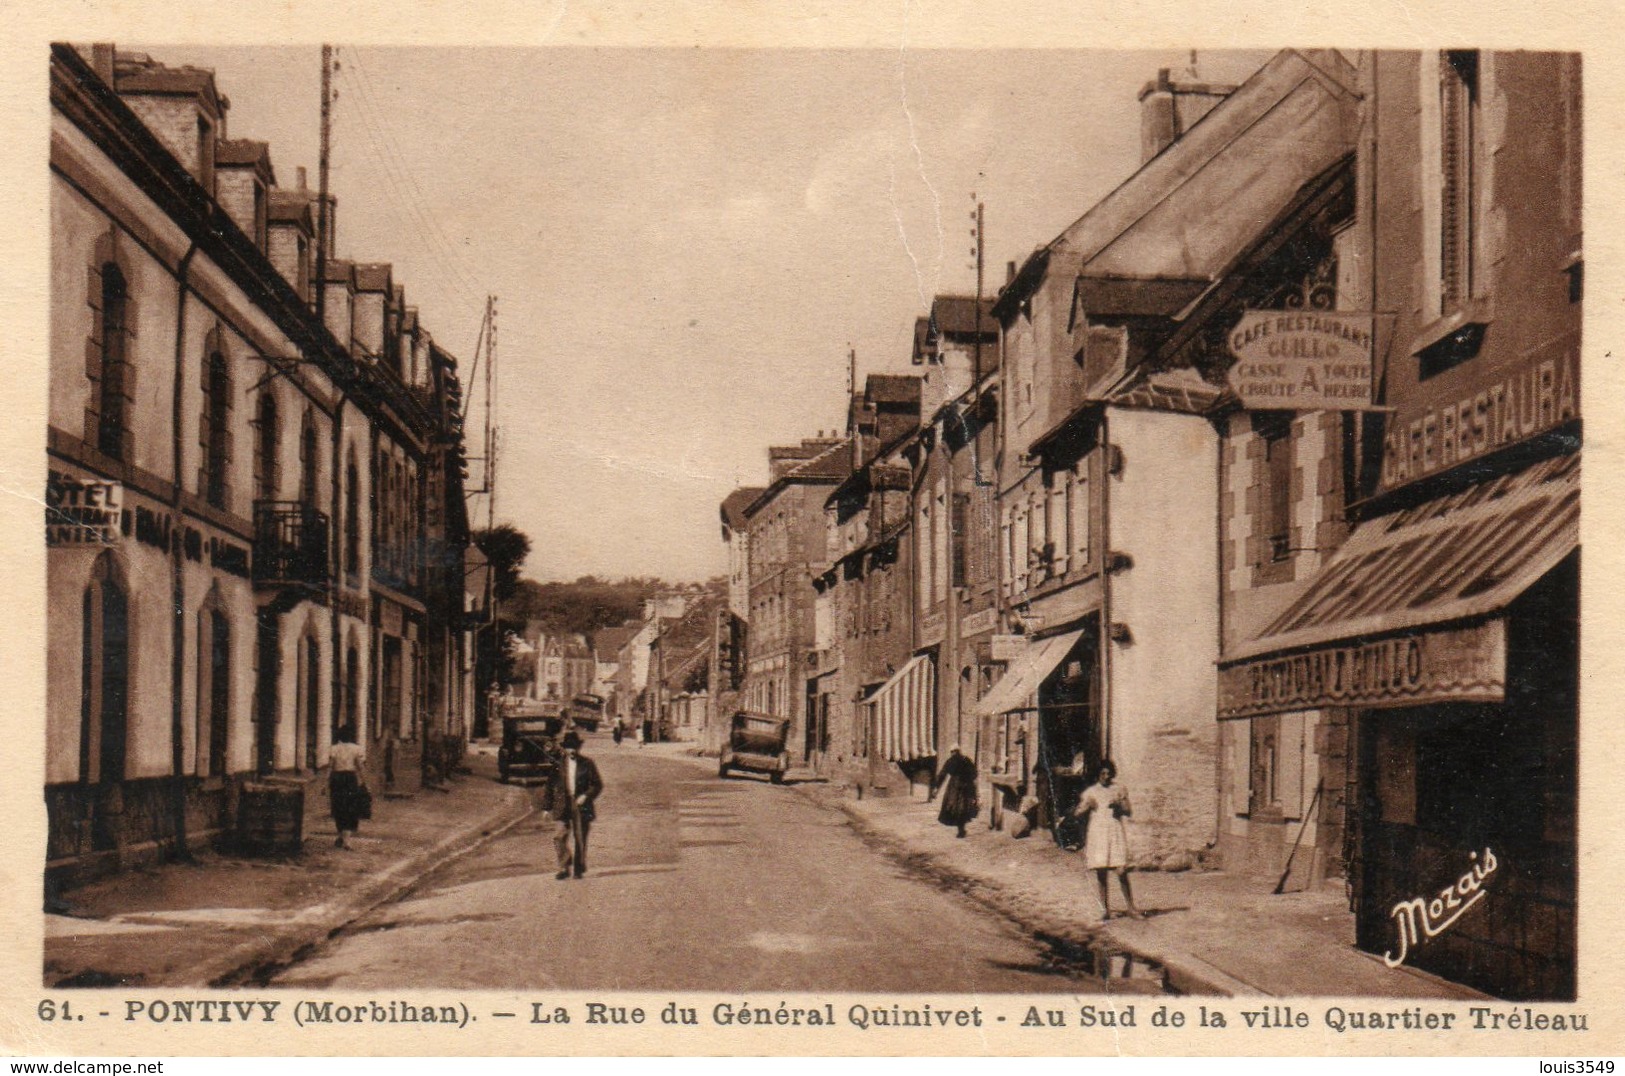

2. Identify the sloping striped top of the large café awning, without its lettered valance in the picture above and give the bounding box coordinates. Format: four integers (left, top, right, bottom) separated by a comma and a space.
1220, 455, 1580, 665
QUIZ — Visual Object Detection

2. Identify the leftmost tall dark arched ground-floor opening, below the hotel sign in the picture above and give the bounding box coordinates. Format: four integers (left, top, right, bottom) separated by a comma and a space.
80, 553, 130, 783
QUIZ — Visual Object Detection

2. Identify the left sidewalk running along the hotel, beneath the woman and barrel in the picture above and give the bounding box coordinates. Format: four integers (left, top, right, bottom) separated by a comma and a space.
44, 757, 531, 987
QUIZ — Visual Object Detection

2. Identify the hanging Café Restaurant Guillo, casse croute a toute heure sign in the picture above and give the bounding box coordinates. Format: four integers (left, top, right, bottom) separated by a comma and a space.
1230, 310, 1372, 411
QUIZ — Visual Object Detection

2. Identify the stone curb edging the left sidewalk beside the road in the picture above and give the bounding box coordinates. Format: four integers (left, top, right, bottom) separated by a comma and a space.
164, 788, 535, 987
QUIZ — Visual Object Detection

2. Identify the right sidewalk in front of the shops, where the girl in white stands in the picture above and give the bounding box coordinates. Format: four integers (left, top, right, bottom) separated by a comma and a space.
795, 783, 1485, 1000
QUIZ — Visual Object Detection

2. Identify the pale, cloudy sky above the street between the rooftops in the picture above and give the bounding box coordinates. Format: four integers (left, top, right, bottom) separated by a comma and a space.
143, 42, 1269, 580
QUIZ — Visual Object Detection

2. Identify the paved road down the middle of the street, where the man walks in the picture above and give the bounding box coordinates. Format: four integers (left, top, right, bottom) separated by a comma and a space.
271, 736, 1149, 995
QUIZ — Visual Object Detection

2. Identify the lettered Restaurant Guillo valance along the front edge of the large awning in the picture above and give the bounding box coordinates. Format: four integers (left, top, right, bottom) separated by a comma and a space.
1219, 619, 1506, 718
